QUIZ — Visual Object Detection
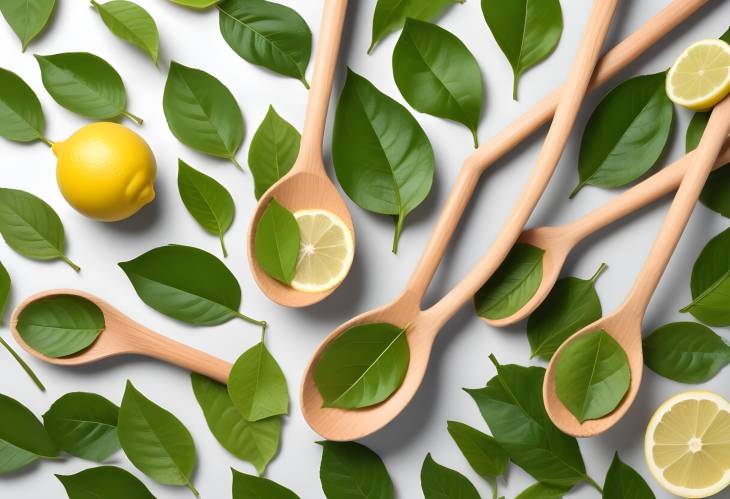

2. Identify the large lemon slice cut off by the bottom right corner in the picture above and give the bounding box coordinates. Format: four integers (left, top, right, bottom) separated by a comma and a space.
644, 391, 730, 498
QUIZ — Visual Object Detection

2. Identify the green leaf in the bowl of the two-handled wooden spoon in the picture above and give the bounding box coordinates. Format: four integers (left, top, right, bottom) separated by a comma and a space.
314, 323, 410, 409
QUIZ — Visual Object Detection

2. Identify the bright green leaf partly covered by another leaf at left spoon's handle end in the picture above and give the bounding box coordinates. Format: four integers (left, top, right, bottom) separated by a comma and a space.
190, 373, 281, 473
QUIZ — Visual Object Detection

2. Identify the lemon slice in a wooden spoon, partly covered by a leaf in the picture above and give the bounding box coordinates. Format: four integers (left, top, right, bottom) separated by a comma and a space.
291, 210, 355, 293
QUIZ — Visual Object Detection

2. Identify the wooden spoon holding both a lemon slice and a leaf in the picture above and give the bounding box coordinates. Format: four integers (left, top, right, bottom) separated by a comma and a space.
248, 0, 355, 307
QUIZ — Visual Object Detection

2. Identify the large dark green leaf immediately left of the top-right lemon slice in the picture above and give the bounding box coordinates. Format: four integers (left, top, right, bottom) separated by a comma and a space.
570, 72, 674, 197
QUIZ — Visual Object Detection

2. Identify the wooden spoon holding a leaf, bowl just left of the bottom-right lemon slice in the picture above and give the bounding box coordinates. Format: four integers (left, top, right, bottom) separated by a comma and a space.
543, 97, 730, 437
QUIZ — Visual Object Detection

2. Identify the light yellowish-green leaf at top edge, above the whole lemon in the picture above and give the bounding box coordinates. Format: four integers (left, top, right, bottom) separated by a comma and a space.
91, 0, 160, 64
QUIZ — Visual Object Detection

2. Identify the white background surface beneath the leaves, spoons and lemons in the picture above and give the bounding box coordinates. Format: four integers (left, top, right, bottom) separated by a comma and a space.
0, 0, 730, 499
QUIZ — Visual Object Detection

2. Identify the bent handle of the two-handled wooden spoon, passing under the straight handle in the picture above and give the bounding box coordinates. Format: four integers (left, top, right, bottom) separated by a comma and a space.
406, 0, 709, 303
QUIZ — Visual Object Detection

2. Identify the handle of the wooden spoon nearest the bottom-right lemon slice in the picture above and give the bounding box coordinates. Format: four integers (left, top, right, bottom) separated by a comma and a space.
621, 97, 730, 317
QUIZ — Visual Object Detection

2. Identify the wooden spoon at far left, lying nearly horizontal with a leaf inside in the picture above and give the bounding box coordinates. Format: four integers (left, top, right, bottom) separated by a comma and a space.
10, 289, 232, 383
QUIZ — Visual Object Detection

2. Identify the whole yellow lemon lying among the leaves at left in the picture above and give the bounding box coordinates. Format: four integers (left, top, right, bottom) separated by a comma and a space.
53, 122, 157, 222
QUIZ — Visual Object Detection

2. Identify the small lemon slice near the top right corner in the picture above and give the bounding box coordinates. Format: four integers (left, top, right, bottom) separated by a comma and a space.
667, 40, 730, 111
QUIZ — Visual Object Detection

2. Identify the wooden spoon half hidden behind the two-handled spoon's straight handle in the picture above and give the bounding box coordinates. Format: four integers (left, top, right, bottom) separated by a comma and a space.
481, 140, 730, 327
